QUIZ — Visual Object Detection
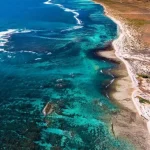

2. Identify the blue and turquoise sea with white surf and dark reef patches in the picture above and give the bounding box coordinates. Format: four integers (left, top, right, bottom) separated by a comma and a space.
0, 0, 133, 150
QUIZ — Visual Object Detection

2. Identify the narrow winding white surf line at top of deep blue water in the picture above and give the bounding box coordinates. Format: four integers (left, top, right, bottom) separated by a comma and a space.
44, 0, 82, 25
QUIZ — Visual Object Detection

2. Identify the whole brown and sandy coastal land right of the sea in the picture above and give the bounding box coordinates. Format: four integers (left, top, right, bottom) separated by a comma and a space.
96, 0, 150, 150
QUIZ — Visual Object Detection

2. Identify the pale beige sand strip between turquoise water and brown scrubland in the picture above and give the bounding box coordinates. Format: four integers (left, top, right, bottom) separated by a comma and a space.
95, 0, 150, 150
